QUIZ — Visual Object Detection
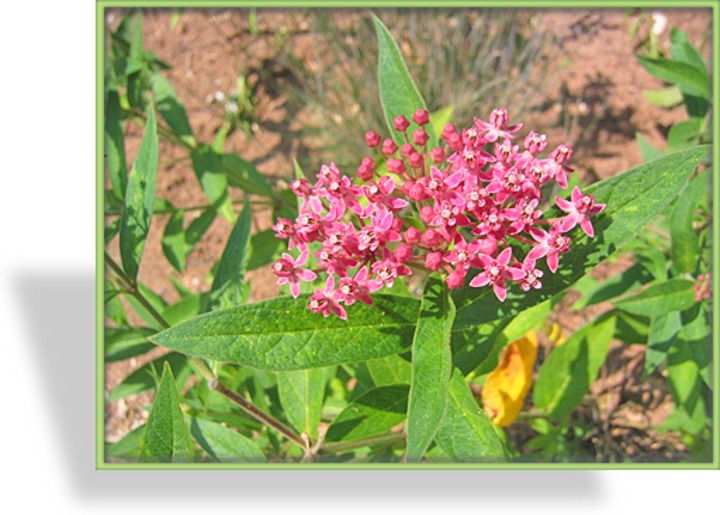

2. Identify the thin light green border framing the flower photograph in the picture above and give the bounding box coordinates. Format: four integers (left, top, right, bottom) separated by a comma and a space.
95, 0, 720, 470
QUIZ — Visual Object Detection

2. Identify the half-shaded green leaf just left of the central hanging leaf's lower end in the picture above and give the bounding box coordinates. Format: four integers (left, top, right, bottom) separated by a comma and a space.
325, 384, 410, 442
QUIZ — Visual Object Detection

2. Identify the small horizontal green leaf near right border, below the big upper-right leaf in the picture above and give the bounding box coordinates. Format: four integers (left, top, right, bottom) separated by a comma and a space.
613, 279, 695, 316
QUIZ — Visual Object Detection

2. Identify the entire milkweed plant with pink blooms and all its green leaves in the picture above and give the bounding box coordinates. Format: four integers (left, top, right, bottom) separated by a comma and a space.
104, 14, 711, 466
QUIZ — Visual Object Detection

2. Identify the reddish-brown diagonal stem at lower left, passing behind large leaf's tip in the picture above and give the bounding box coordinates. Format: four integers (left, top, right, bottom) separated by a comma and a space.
105, 252, 310, 453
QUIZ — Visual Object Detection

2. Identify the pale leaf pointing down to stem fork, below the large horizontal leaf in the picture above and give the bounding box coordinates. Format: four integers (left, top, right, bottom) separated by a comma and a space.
276, 367, 335, 440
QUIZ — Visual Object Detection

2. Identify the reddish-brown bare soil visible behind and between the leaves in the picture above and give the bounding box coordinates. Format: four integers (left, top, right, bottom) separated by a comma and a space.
106, 5, 712, 461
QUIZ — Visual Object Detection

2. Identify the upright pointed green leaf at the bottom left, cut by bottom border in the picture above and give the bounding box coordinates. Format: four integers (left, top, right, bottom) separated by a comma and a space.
140, 363, 193, 462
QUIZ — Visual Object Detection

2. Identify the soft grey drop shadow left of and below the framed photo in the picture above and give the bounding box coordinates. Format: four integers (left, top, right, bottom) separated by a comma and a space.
12, 270, 604, 504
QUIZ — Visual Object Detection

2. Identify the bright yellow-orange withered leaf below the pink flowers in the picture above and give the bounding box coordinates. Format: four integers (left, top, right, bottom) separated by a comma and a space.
481, 331, 538, 427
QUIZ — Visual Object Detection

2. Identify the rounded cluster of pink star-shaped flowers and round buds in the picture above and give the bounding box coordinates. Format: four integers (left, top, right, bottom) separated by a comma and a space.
273, 109, 605, 319
